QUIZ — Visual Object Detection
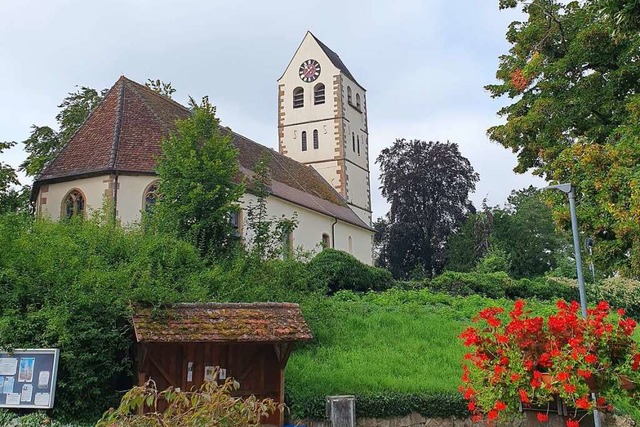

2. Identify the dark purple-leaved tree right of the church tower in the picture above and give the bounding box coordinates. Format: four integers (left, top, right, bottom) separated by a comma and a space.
376, 139, 479, 277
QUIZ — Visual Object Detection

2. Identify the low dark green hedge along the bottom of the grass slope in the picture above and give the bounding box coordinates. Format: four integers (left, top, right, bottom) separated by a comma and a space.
286, 393, 469, 420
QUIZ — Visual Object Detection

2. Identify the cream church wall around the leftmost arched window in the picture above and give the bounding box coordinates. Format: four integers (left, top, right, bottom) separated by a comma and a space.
36, 175, 110, 221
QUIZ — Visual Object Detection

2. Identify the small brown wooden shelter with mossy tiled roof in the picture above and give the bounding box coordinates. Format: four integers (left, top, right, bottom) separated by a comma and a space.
133, 303, 312, 426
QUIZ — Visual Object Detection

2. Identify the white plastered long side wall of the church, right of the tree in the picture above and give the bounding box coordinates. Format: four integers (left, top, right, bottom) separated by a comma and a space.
241, 194, 373, 265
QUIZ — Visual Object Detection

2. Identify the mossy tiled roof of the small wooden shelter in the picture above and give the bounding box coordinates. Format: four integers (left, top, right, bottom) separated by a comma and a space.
133, 303, 312, 343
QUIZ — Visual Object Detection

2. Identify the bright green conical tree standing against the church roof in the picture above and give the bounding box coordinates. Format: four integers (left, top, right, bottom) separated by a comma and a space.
151, 97, 244, 256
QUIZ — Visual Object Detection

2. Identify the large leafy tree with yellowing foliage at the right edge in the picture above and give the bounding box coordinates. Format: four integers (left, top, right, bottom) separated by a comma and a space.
487, 0, 640, 276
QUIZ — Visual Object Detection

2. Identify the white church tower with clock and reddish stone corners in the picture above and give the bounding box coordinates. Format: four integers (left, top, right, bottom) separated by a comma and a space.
278, 32, 371, 225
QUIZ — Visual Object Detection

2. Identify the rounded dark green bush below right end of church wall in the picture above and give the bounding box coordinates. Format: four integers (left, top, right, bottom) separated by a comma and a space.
308, 249, 394, 294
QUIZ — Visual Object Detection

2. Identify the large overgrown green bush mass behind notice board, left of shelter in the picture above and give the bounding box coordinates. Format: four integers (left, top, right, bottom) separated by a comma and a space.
0, 215, 208, 420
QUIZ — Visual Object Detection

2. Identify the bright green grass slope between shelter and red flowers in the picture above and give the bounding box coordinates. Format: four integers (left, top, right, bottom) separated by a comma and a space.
286, 289, 552, 412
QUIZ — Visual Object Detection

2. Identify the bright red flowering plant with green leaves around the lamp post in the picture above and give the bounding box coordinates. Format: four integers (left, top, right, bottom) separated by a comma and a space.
460, 300, 640, 427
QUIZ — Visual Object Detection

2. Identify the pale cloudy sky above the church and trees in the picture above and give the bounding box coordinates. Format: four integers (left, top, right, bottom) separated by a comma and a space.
0, 0, 545, 218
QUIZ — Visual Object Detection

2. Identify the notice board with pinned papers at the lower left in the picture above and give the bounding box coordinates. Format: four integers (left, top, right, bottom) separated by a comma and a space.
0, 349, 60, 409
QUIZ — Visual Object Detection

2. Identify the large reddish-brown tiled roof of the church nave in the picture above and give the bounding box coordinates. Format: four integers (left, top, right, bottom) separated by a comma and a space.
32, 76, 370, 228
